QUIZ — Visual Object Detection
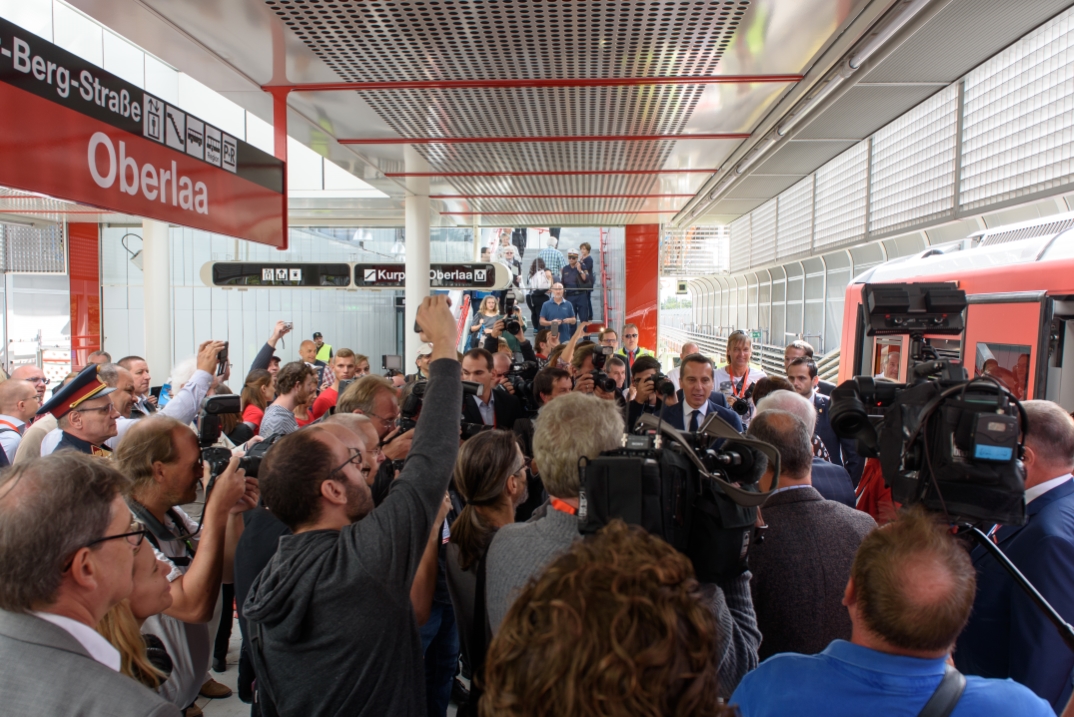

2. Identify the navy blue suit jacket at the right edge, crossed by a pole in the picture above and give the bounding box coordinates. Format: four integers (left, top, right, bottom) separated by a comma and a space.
955, 481, 1074, 713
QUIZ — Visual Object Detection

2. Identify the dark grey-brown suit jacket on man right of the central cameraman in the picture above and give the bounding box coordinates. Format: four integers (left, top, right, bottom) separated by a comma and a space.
750, 486, 876, 660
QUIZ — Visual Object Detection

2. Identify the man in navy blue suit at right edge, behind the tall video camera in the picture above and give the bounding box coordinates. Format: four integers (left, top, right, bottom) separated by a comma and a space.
955, 400, 1074, 713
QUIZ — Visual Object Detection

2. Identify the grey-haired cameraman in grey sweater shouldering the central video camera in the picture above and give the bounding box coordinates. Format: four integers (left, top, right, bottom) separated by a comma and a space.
485, 393, 760, 697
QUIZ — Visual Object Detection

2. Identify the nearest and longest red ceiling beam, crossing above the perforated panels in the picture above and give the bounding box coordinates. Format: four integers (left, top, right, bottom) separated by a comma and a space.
272, 75, 802, 92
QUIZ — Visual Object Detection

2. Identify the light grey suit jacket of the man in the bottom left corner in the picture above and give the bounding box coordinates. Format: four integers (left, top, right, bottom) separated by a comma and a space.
0, 610, 179, 717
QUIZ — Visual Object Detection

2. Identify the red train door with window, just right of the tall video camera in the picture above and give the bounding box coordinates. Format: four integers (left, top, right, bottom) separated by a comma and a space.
962, 291, 1049, 399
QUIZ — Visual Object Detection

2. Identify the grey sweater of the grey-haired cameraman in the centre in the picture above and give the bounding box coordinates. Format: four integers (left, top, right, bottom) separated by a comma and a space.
485, 510, 760, 697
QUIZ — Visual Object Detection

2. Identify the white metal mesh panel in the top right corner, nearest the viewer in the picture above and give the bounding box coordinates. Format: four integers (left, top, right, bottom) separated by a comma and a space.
960, 10, 1074, 209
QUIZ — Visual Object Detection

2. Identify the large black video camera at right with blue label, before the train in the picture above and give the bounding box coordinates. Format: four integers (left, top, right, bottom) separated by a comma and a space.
828, 283, 1026, 525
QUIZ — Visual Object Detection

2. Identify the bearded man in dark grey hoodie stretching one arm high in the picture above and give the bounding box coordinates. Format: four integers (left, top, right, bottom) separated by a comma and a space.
243, 296, 463, 717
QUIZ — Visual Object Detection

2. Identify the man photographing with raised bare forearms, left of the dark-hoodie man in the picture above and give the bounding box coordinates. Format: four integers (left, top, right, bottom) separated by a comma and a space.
115, 415, 258, 708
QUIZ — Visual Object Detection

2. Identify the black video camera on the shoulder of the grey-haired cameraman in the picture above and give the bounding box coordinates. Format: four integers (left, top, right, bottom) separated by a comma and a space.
578, 407, 780, 583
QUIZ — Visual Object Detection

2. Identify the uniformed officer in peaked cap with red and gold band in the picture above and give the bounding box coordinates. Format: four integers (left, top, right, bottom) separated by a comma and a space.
38, 364, 119, 457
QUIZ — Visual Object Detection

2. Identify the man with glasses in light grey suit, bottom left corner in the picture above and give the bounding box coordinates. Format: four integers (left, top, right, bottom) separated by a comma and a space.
0, 452, 180, 717
